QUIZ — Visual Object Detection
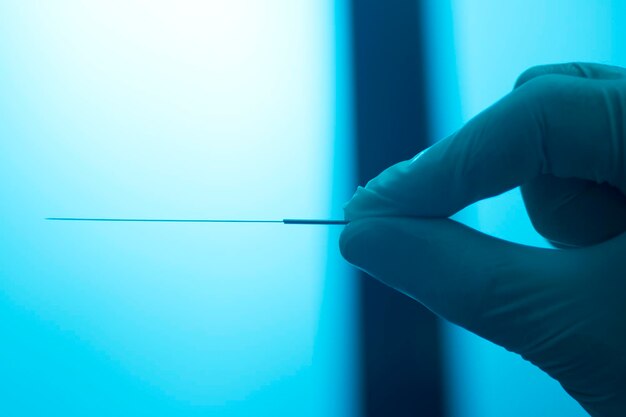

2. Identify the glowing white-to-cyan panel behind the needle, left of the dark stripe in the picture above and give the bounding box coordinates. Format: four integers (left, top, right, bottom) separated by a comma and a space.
0, 0, 354, 416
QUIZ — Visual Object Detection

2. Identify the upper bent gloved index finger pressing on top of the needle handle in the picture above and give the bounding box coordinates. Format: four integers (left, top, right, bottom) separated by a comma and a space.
344, 64, 626, 220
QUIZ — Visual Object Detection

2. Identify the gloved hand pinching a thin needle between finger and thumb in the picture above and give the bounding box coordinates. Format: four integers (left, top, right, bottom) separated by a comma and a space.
340, 64, 626, 417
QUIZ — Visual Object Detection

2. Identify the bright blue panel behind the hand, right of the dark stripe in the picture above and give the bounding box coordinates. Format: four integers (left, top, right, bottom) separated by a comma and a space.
425, 0, 626, 417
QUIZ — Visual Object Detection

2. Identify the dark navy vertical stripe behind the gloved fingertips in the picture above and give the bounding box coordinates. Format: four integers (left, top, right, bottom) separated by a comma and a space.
352, 0, 444, 417
